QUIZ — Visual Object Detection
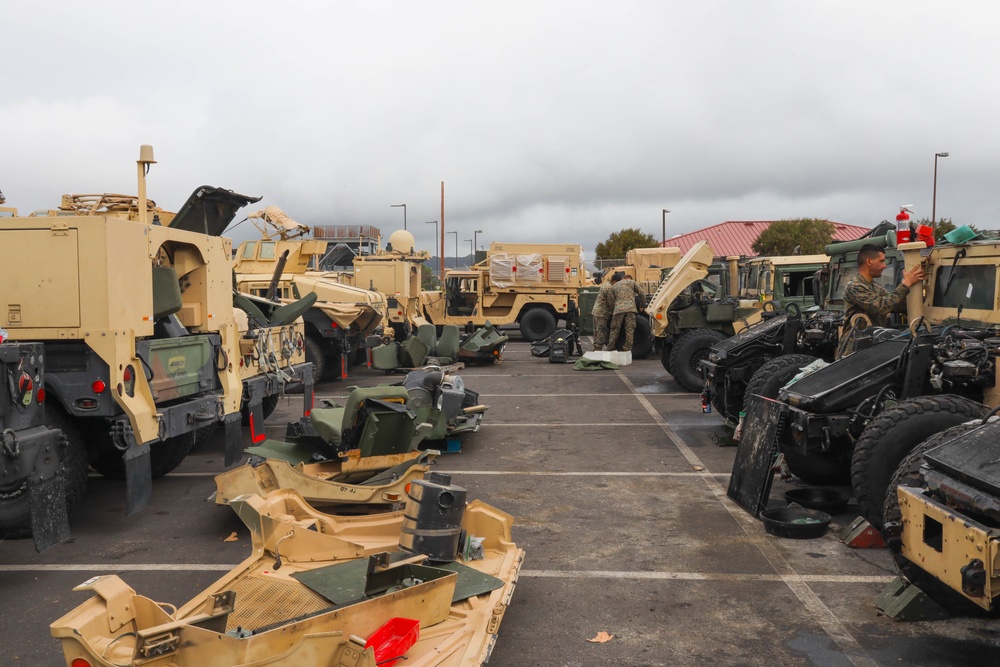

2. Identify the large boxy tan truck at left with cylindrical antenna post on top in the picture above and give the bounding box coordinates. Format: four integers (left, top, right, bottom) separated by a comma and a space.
0, 146, 314, 544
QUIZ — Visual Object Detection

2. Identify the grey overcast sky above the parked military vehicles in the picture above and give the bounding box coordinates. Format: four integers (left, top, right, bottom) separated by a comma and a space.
0, 0, 1000, 258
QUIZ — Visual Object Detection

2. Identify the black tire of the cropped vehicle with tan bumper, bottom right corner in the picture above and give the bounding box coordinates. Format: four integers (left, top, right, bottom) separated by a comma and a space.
882, 421, 982, 615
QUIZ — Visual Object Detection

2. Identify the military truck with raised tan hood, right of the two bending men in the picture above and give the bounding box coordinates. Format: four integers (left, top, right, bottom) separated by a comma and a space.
646, 241, 826, 392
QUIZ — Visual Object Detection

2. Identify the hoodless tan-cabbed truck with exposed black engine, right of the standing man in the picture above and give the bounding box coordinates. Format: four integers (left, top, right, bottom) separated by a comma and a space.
744, 239, 1000, 527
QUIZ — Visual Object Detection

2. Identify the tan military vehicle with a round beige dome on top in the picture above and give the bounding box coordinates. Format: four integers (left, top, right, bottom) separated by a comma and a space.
340, 229, 430, 341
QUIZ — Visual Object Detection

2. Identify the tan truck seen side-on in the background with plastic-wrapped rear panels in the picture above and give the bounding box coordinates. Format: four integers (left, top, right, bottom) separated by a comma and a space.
420, 242, 587, 342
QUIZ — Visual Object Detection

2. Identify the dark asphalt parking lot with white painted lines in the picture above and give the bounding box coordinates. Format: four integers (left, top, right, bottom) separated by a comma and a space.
0, 341, 1000, 667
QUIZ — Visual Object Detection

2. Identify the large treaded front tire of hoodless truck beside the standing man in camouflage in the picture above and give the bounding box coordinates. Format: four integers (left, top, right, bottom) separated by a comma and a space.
851, 394, 989, 530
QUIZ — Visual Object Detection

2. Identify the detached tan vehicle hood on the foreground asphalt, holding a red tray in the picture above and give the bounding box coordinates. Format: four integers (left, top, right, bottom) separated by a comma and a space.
50, 475, 524, 667
